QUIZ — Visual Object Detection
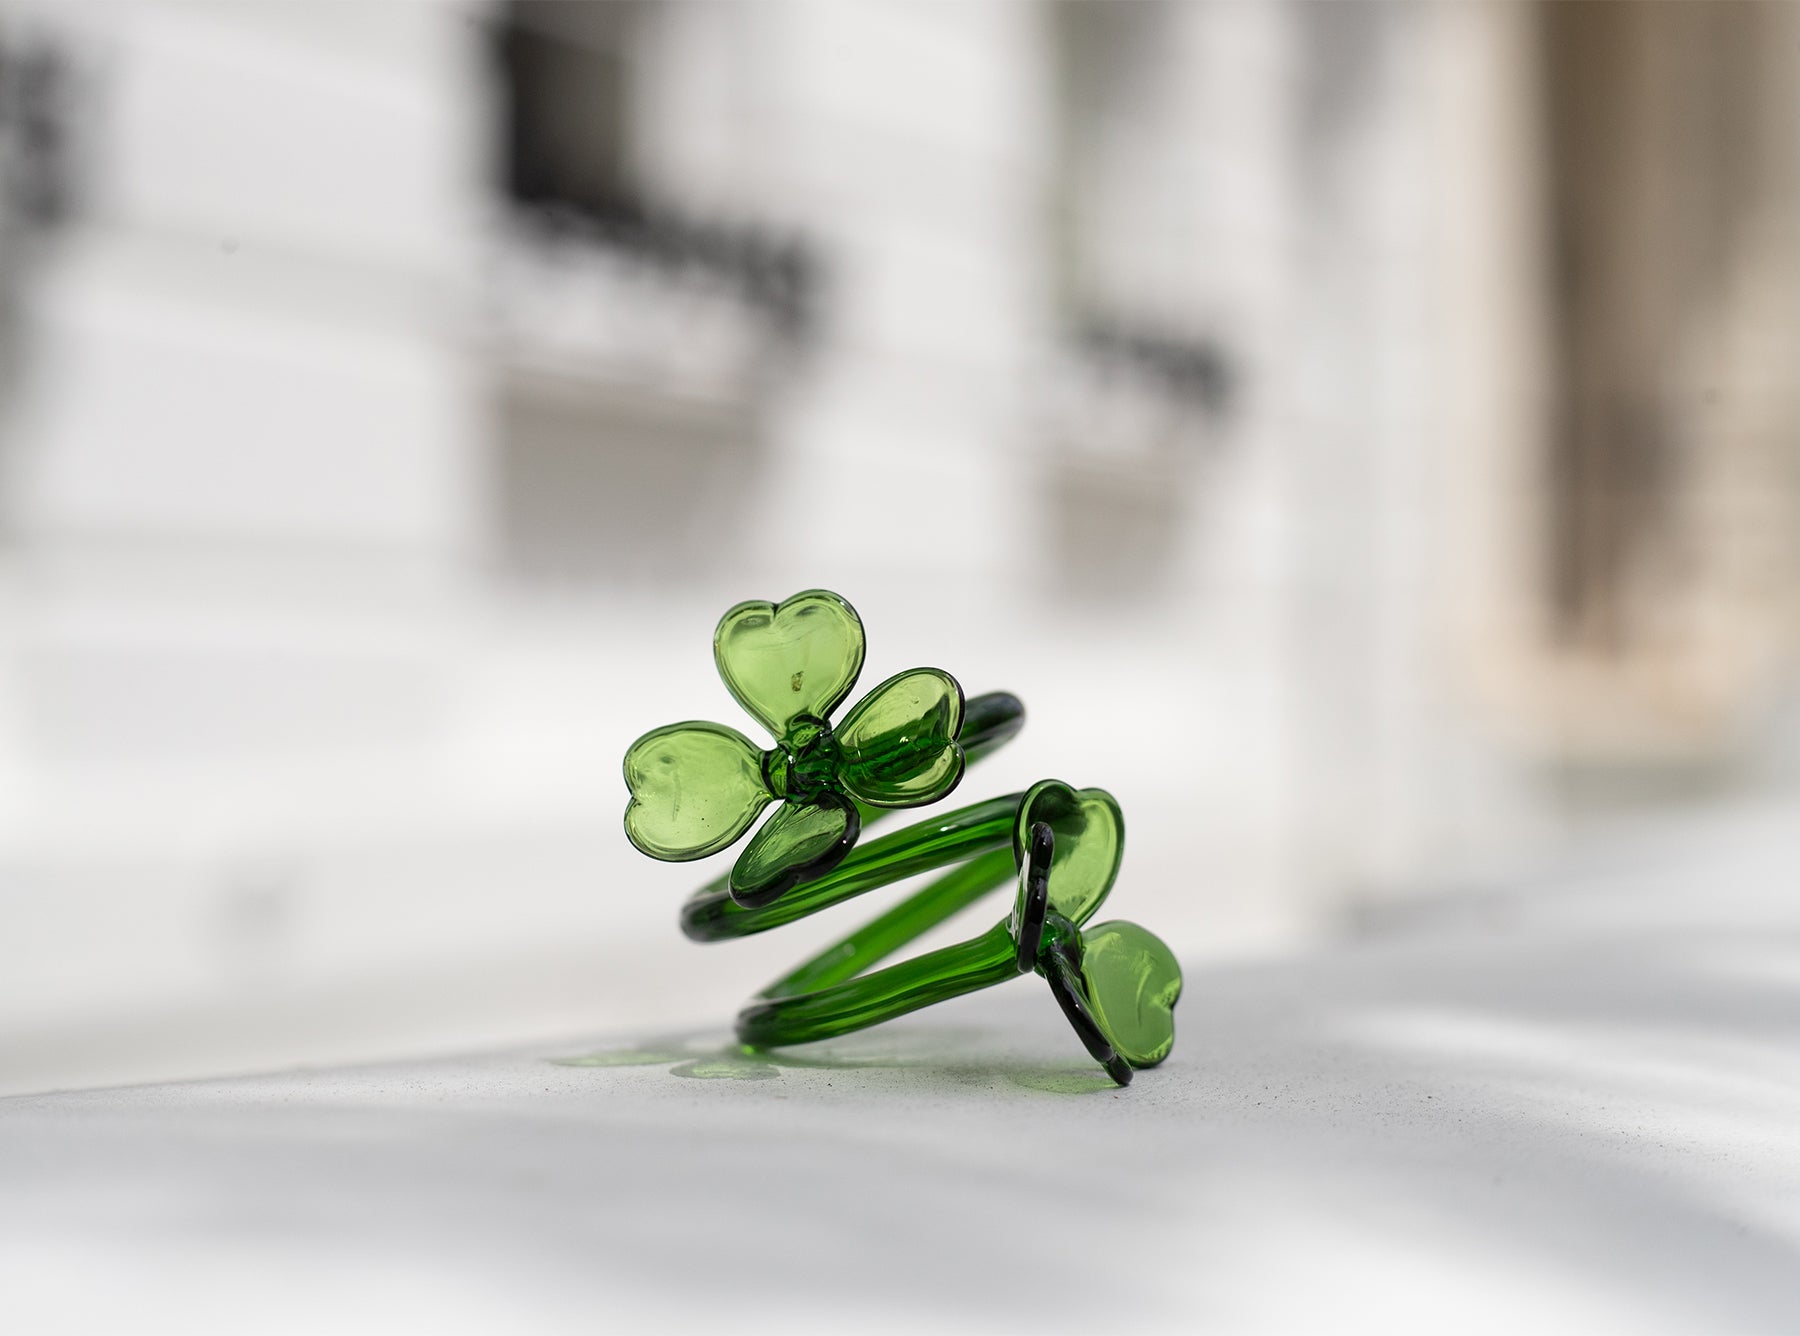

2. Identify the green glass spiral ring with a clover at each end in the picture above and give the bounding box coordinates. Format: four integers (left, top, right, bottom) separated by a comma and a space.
625, 589, 1181, 1086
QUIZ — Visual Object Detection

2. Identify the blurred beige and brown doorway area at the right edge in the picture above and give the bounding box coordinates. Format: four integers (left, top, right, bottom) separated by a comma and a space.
1541, 4, 1800, 785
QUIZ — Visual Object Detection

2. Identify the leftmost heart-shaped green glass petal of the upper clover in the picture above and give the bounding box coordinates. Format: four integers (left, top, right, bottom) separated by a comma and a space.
625, 722, 772, 862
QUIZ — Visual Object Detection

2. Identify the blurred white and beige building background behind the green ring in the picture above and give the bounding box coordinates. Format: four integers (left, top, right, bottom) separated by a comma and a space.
0, 0, 1800, 1091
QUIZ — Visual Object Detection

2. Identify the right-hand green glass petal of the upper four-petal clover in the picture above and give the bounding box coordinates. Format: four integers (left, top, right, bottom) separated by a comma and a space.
835, 668, 963, 807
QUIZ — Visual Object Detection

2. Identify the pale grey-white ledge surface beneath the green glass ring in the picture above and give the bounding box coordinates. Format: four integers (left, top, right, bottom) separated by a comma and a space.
0, 799, 1800, 1332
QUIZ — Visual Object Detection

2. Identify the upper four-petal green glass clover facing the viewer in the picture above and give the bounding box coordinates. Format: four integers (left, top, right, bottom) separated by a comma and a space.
625, 589, 965, 906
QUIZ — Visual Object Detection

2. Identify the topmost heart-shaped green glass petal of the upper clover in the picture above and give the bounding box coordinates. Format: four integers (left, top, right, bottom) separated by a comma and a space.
713, 589, 862, 740
